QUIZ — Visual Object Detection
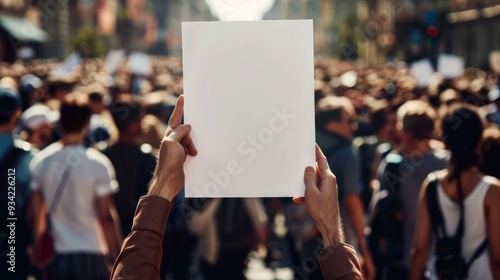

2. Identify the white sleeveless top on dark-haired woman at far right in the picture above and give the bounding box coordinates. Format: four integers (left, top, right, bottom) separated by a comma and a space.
427, 176, 495, 280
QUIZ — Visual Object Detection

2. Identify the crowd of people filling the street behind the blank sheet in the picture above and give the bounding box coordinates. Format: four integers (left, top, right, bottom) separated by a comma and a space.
0, 57, 500, 280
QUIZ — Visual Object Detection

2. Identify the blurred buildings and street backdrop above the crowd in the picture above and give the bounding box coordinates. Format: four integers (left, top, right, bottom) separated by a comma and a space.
0, 0, 500, 67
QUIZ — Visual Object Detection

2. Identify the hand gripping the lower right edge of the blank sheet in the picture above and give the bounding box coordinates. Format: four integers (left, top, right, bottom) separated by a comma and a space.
293, 145, 344, 247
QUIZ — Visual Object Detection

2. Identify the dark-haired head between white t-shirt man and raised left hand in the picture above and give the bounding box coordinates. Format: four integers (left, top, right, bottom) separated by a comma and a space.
109, 94, 142, 133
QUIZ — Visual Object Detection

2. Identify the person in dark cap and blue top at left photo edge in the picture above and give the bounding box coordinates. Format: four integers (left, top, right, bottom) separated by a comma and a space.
0, 87, 33, 280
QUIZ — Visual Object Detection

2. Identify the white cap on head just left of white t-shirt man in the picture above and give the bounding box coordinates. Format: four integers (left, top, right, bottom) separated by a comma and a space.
16, 104, 59, 132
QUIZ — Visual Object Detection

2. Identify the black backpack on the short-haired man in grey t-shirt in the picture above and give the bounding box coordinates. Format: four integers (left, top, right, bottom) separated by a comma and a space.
368, 153, 403, 266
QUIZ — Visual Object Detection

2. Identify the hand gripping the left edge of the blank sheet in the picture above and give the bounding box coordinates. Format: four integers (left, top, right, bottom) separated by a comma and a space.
148, 95, 198, 201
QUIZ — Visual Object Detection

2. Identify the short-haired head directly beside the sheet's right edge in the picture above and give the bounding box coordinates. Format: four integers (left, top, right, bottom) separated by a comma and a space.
316, 96, 357, 141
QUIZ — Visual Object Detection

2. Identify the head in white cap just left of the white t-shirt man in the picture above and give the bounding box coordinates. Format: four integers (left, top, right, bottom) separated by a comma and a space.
15, 104, 59, 150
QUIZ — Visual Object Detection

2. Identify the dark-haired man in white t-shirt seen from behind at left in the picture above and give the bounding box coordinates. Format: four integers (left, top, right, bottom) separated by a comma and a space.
30, 94, 122, 280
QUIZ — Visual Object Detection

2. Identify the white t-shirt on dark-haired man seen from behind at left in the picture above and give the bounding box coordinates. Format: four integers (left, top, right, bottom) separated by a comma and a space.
30, 142, 118, 254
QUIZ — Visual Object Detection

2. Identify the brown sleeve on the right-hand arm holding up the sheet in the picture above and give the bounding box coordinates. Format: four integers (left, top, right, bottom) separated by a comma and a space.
318, 243, 363, 280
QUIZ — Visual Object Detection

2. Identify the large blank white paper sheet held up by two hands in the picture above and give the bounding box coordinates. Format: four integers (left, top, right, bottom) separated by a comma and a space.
182, 20, 315, 197
